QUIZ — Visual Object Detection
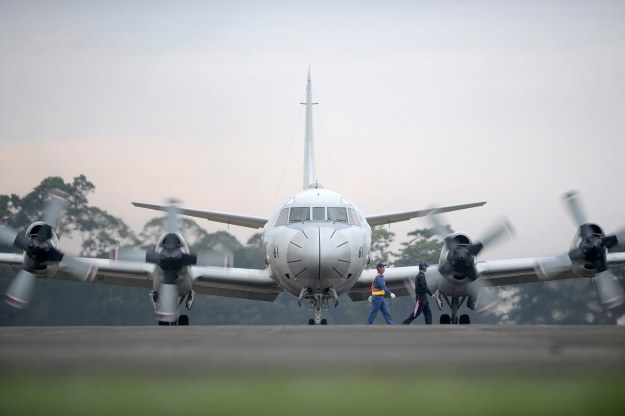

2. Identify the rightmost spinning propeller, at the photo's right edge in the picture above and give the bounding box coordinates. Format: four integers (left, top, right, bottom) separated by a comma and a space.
535, 191, 625, 308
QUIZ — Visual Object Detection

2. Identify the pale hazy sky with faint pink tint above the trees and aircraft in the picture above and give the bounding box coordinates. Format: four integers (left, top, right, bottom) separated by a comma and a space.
0, 0, 625, 259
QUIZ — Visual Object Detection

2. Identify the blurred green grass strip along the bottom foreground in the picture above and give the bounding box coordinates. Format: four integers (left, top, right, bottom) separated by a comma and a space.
0, 373, 625, 416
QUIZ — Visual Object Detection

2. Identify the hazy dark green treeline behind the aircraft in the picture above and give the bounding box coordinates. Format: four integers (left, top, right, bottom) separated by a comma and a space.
0, 175, 625, 326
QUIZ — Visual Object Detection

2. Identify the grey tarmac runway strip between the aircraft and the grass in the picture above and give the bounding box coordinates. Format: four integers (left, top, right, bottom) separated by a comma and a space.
0, 325, 625, 376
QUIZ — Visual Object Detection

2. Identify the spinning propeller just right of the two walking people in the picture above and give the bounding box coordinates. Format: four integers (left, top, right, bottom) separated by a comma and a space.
428, 210, 514, 314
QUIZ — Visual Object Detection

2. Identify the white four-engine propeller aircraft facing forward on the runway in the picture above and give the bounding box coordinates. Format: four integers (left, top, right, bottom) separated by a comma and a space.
0, 70, 625, 325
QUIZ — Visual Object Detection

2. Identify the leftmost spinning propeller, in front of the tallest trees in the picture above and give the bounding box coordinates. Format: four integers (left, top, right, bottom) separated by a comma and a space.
0, 189, 97, 308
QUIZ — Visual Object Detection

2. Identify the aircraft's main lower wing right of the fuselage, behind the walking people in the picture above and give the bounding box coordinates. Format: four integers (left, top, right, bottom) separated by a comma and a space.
347, 253, 625, 301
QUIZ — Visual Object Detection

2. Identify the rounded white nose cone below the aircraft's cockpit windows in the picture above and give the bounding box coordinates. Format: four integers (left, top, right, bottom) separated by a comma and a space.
287, 227, 351, 288
